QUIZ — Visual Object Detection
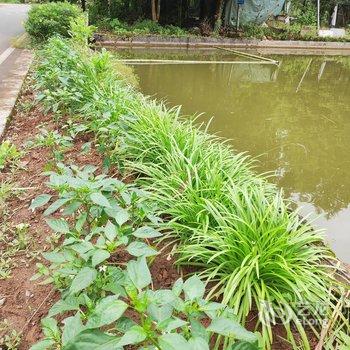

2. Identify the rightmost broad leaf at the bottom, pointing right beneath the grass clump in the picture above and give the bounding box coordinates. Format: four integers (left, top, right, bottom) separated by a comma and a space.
207, 317, 258, 342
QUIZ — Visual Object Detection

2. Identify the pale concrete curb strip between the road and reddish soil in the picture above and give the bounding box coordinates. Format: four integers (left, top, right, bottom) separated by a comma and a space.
0, 50, 33, 140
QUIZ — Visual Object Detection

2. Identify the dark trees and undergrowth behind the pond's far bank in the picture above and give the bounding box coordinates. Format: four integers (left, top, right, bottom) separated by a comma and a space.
18, 0, 350, 40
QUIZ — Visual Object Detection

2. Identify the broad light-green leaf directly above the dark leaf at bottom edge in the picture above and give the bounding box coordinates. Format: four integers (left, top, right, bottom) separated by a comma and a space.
86, 295, 128, 328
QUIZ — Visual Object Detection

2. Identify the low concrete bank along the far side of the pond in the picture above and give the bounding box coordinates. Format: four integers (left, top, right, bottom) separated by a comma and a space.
96, 34, 350, 55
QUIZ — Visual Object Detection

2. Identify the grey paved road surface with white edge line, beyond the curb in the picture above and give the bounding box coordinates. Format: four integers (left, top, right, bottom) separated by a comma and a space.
0, 4, 29, 82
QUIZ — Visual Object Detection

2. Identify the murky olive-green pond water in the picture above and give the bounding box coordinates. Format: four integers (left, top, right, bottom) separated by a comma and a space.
117, 50, 350, 263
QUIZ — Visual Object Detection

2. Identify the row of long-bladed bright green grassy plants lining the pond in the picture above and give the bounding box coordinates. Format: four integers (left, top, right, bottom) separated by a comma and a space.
32, 20, 348, 349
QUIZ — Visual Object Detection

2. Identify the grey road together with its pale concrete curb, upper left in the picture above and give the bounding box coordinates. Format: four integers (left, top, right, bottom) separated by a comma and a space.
0, 4, 32, 138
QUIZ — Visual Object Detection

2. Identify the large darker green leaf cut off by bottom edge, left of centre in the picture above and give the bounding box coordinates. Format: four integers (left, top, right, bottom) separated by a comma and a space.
63, 329, 122, 350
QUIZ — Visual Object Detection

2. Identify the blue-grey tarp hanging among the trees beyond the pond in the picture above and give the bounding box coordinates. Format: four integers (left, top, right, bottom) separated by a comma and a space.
225, 0, 285, 26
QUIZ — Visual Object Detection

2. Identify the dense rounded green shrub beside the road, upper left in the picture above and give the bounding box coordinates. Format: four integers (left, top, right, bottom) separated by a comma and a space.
25, 2, 81, 42
